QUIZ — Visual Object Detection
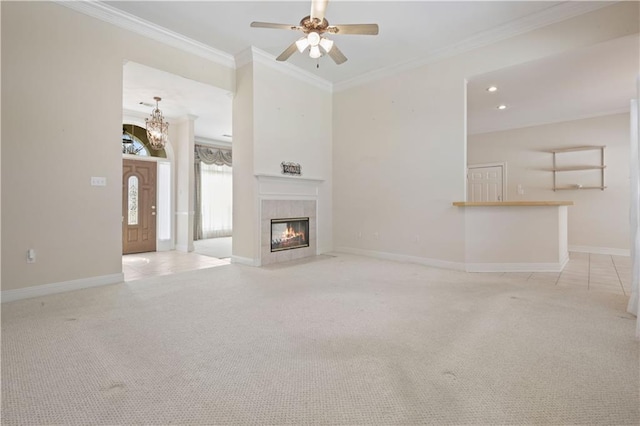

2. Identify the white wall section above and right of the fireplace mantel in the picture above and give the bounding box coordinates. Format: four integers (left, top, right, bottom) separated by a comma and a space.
254, 62, 333, 253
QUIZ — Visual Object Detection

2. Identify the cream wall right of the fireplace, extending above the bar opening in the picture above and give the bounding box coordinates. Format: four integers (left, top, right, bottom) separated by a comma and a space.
333, 2, 638, 265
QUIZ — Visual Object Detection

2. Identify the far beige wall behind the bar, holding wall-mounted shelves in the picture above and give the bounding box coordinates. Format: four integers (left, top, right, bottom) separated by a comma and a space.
467, 113, 629, 253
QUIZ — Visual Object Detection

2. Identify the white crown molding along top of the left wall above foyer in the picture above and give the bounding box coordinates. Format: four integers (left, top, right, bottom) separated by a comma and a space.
54, 0, 235, 68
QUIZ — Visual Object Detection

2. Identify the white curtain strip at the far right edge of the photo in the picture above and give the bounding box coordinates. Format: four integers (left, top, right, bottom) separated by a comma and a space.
627, 98, 640, 338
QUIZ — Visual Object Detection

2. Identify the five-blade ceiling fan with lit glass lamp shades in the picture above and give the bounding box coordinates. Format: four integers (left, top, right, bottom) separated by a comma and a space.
251, 0, 378, 65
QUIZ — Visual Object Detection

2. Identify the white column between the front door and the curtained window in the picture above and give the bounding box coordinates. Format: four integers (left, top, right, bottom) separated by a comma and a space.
174, 115, 198, 252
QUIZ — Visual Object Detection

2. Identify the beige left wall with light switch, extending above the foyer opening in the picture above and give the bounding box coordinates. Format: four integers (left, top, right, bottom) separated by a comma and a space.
0, 2, 235, 290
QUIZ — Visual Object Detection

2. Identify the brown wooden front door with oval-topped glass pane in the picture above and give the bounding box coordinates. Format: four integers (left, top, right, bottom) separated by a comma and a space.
122, 160, 156, 254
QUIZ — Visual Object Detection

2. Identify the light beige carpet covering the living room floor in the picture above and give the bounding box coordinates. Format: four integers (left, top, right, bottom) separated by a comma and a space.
2, 255, 640, 425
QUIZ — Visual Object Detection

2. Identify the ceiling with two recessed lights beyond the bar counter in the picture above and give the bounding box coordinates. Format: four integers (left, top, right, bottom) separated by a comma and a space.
467, 34, 640, 134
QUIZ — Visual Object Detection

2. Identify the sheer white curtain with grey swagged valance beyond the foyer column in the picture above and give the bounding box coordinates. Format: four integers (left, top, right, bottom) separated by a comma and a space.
193, 145, 233, 240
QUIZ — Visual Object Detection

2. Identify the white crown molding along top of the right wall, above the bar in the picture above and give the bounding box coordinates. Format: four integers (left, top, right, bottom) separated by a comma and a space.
333, 1, 617, 92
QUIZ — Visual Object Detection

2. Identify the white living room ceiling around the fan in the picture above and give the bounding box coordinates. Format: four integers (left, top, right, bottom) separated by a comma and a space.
105, 0, 561, 83
